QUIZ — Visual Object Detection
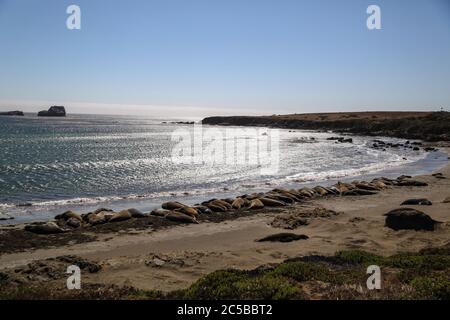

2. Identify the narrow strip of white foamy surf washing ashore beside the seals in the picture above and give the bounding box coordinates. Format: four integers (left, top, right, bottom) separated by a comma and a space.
0, 135, 449, 226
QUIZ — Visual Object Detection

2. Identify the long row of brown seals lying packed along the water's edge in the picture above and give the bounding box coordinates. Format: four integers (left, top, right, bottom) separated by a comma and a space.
25, 176, 432, 234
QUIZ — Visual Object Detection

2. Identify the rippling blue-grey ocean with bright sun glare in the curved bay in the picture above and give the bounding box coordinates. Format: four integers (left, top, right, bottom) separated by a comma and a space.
0, 115, 448, 223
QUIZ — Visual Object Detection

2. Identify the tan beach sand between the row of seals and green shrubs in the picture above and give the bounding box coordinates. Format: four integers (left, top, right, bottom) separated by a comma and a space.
0, 148, 450, 291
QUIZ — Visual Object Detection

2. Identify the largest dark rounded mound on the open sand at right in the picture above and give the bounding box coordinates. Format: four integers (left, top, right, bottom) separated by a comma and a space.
385, 208, 439, 231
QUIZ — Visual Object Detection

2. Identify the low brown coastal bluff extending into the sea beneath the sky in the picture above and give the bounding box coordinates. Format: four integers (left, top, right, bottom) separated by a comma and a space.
202, 111, 450, 141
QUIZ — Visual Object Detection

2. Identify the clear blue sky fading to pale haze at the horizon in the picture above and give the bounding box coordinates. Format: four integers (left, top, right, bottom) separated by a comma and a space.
0, 0, 450, 116
